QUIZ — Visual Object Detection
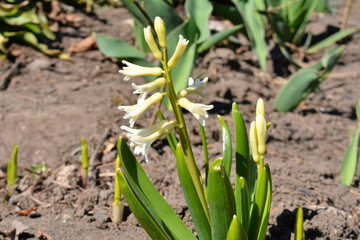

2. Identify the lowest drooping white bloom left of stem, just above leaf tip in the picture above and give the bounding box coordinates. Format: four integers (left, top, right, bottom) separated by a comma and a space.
121, 120, 174, 162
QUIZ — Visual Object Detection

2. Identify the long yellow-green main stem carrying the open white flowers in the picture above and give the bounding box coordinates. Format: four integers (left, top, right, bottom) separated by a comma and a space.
162, 49, 210, 219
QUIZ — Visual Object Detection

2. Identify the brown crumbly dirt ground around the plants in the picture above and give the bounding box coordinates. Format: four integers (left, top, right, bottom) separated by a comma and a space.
0, 1, 360, 240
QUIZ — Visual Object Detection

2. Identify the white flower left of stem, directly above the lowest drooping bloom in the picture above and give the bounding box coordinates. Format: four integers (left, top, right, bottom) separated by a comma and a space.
118, 93, 163, 127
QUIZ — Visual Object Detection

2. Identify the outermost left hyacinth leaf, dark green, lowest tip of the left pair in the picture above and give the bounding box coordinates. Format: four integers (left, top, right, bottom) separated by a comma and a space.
116, 169, 172, 240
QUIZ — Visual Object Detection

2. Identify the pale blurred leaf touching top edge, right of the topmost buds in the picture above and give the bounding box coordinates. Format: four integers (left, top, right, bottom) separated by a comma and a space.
185, 0, 213, 43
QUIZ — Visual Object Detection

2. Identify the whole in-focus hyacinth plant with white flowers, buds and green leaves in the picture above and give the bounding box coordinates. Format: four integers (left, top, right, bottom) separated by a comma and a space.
116, 17, 272, 240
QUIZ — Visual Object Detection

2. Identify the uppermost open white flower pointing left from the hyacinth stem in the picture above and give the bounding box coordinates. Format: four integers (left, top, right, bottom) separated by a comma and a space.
119, 60, 164, 81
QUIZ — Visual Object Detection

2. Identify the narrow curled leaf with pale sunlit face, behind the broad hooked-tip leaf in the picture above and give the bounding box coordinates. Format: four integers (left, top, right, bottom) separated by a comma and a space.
218, 115, 232, 177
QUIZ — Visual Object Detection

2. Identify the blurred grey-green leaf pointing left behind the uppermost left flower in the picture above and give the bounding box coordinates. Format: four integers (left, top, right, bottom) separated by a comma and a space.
95, 34, 146, 60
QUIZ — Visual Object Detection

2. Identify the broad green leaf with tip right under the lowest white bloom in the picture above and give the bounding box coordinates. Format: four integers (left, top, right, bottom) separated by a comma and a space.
118, 138, 196, 240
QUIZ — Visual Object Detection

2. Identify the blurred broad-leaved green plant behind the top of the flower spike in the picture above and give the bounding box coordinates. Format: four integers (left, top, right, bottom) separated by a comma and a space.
96, 0, 243, 106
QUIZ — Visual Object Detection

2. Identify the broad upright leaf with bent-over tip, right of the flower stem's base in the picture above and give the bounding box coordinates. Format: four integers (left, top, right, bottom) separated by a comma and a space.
208, 158, 235, 240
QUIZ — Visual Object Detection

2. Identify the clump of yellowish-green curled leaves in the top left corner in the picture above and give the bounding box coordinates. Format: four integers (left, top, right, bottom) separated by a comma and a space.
0, 0, 69, 59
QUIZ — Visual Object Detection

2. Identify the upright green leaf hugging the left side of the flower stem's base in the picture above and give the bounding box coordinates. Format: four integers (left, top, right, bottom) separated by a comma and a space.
176, 144, 211, 240
